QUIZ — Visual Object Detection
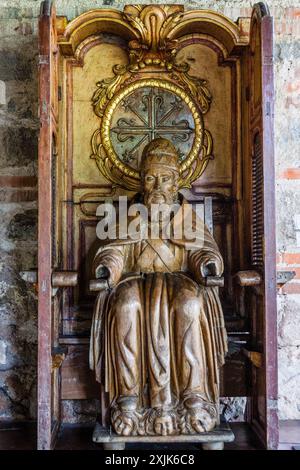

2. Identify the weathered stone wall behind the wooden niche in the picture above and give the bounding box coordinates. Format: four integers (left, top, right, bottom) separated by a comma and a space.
0, 0, 300, 421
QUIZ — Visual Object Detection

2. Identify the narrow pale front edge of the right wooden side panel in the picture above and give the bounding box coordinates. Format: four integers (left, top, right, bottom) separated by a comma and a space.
261, 4, 279, 449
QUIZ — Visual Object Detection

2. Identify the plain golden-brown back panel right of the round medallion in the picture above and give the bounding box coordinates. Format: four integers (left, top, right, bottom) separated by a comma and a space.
176, 40, 235, 191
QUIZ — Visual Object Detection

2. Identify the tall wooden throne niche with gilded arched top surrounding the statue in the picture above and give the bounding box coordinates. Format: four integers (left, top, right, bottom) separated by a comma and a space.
38, 2, 278, 449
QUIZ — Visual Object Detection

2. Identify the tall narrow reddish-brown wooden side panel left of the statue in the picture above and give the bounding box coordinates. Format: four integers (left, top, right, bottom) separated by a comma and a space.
38, 1, 59, 449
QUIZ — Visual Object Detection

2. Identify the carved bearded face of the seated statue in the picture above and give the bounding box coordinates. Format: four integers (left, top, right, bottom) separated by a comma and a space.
143, 164, 178, 209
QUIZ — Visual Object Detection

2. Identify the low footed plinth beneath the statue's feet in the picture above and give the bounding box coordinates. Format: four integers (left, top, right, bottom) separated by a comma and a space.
93, 423, 234, 450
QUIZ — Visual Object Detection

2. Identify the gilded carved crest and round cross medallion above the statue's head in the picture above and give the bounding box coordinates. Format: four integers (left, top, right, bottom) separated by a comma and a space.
91, 5, 213, 191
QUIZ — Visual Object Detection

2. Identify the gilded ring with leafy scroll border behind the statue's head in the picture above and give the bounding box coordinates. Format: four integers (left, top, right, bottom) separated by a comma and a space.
91, 72, 213, 191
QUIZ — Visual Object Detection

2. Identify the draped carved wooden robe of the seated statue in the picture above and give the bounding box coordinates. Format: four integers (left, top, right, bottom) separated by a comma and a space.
90, 201, 227, 434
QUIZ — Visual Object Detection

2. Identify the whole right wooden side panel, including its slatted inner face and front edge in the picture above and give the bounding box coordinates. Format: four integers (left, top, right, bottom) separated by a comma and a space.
249, 3, 278, 449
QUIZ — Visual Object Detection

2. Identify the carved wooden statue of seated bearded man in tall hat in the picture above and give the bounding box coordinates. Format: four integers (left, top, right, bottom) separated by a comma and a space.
90, 138, 227, 436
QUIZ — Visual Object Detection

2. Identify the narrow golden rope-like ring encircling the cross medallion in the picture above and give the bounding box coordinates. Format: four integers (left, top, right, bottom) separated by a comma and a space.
101, 78, 204, 180
